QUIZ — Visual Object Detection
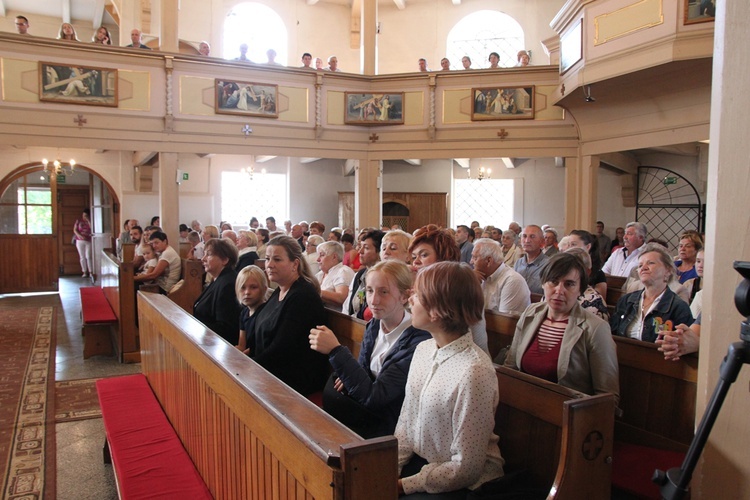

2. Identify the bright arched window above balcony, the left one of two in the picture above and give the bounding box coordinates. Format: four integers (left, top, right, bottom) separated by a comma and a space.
224, 2, 289, 65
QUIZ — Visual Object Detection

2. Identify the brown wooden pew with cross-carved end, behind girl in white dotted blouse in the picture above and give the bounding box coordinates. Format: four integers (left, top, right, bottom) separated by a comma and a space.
326, 309, 615, 499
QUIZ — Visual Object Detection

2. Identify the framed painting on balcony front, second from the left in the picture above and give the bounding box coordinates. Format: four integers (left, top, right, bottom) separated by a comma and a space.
214, 78, 279, 118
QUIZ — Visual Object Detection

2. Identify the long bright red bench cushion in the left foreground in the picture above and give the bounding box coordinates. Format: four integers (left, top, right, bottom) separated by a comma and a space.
96, 375, 212, 499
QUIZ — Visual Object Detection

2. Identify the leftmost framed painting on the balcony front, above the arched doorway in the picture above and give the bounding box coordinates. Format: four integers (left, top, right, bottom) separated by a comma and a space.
39, 61, 118, 107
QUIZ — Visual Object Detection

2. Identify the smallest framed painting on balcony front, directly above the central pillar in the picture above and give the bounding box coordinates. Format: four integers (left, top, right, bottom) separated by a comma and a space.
344, 92, 404, 125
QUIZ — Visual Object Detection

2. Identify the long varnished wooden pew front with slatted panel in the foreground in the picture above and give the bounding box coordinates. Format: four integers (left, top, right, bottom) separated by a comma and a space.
138, 293, 398, 499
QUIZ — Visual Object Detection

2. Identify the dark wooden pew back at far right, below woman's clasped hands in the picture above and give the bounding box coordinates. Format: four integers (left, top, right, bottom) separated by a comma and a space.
614, 337, 698, 453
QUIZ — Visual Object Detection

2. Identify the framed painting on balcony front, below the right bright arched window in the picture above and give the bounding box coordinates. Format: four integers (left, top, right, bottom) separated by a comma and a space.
471, 85, 534, 121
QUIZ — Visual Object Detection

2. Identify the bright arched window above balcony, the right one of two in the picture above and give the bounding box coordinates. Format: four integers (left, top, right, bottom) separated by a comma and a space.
445, 10, 526, 69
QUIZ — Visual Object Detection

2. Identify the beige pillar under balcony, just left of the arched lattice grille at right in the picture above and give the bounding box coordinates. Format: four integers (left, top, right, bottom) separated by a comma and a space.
565, 156, 599, 234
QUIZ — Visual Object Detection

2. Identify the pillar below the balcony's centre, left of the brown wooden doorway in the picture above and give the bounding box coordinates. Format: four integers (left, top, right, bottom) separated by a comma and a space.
354, 160, 383, 229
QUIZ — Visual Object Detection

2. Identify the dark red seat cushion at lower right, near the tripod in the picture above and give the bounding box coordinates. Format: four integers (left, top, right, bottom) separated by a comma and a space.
612, 442, 685, 500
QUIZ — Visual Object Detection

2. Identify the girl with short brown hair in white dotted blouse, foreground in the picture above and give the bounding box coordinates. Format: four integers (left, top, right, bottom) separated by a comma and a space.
394, 262, 503, 498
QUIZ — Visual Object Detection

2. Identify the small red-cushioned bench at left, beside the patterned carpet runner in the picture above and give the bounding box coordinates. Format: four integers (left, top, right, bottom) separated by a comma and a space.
79, 286, 117, 359
